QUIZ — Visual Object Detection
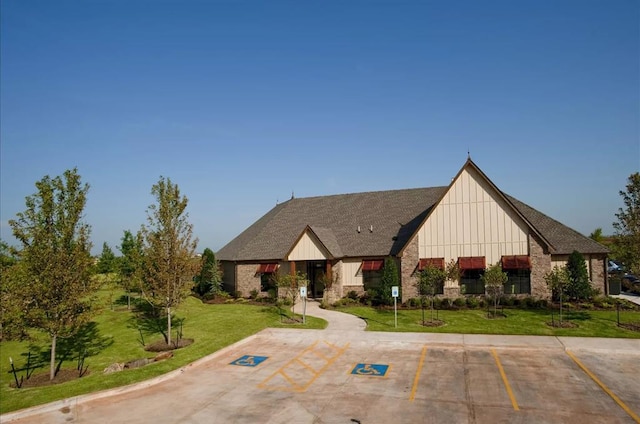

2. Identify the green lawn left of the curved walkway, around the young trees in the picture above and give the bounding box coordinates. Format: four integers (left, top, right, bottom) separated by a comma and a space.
0, 291, 327, 413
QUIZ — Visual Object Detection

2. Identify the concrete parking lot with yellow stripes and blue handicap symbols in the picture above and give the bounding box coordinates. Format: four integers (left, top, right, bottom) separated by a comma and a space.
2, 329, 640, 423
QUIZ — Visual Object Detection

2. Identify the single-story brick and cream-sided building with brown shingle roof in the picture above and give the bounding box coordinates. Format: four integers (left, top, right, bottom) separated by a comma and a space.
216, 158, 608, 301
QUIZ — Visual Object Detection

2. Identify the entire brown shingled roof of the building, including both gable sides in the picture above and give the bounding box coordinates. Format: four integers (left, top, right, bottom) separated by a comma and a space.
216, 159, 608, 261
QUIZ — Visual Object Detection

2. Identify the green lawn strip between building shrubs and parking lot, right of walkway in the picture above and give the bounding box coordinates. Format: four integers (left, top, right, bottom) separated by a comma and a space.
337, 306, 640, 338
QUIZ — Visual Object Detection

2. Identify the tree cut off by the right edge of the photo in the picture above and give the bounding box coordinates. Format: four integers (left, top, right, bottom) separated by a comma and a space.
612, 172, 640, 274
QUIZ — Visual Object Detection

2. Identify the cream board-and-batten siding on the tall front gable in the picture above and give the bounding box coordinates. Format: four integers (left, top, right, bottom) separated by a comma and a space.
418, 168, 529, 266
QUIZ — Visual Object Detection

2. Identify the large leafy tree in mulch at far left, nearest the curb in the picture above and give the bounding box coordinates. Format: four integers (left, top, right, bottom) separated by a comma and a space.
9, 169, 97, 380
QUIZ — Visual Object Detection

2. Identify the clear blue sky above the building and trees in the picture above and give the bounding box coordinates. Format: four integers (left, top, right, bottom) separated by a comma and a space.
0, 0, 640, 253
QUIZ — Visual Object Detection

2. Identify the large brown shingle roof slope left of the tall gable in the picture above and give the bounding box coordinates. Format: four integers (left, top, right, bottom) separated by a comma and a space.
216, 187, 447, 261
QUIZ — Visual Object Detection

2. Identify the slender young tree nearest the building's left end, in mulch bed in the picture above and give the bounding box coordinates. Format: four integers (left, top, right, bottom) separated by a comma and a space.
140, 177, 198, 345
